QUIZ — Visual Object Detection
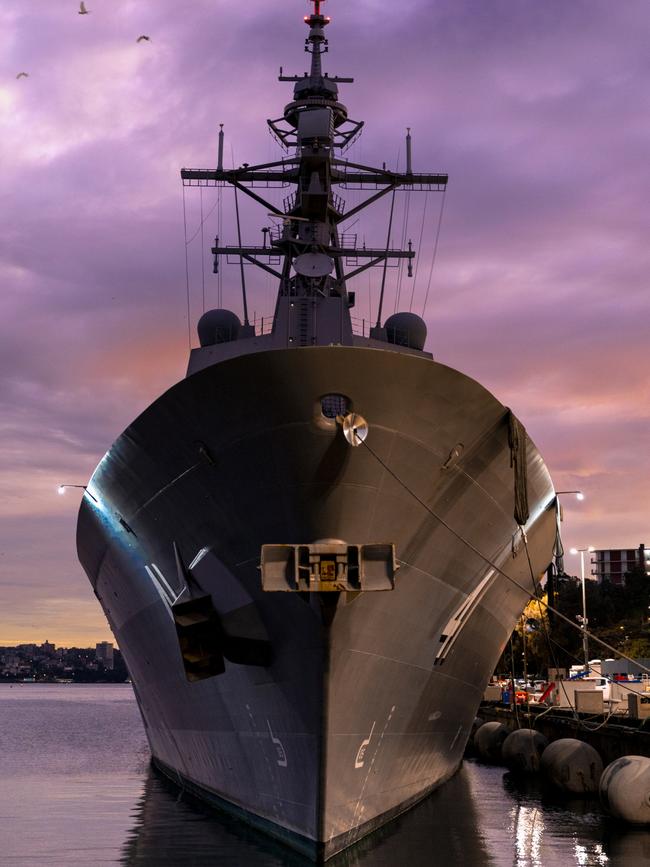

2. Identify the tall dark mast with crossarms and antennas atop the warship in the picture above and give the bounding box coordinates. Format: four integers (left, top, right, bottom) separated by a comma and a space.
181, 0, 447, 324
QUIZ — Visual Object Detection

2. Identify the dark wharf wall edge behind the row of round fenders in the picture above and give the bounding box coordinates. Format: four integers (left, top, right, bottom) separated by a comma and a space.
478, 701, 650, 765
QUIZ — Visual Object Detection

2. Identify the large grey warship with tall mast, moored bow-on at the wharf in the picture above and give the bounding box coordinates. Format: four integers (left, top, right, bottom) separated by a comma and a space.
77, 0, 556, 862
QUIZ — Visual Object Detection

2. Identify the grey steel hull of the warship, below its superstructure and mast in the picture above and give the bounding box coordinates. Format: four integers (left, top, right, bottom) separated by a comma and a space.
77, 346, 555, 857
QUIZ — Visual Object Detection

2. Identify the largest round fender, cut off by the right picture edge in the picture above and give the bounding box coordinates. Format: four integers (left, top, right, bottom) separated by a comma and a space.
599, 756, 650, 825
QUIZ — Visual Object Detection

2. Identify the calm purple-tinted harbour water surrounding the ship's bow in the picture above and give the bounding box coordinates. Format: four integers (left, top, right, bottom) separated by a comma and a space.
0, 684, 650, 867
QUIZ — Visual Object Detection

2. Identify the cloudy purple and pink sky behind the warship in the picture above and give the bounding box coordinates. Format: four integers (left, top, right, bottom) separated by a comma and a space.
0, 0, 650, 645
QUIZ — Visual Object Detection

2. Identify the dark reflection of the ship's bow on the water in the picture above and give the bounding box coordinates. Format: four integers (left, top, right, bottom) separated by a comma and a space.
121, 770, 492, 867
